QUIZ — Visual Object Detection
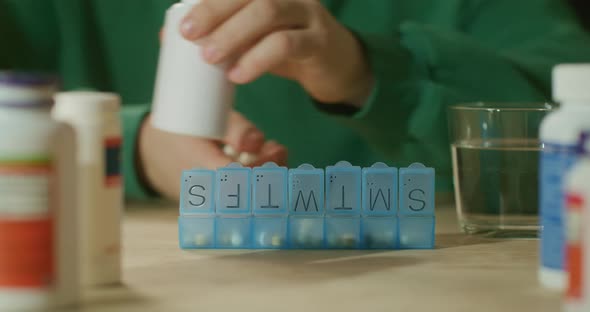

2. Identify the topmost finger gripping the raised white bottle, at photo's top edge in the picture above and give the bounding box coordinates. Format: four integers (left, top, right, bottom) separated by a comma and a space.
180, 0, 251, 41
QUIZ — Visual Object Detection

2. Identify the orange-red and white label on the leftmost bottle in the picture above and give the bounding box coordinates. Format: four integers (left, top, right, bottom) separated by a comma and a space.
0, 157, 55, 288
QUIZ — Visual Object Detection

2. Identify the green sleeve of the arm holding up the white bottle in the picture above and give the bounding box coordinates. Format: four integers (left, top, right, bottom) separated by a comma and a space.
322, 0, 590, 182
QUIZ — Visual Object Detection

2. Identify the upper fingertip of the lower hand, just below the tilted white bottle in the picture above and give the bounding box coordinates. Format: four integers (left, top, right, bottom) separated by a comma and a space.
225, 111, 264, 153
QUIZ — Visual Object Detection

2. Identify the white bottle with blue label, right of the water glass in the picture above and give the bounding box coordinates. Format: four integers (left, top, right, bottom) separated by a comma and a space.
539, 64, 590, 289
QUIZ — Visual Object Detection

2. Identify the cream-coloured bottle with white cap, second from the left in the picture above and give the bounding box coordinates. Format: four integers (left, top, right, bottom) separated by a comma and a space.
53, 91, 123, 286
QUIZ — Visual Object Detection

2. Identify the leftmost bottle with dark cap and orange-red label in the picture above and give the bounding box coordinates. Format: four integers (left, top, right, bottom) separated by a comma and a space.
0, 72, 79, 311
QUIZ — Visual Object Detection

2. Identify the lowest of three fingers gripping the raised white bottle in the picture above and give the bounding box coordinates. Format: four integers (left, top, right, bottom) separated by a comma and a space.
229, 30, 318, 84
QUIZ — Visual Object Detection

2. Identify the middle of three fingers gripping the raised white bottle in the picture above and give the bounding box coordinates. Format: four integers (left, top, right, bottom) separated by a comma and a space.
203, 0, 307, 63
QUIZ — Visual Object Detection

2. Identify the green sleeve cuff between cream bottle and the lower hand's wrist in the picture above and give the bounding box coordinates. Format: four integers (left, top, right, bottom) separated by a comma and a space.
121, 104, 156, 199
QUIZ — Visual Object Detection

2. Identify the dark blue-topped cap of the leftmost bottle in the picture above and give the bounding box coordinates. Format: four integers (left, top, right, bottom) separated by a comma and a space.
0, 71, 59, 107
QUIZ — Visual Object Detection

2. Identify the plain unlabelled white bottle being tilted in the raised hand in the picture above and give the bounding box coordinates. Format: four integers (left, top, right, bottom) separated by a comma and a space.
152, 0, 235, 139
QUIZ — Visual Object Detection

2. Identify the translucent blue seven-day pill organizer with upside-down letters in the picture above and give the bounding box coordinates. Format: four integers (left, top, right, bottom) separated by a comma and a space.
178, 161, 435, 249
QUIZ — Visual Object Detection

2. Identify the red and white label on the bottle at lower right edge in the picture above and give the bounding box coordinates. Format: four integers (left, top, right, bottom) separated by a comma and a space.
566, 194, 585, 301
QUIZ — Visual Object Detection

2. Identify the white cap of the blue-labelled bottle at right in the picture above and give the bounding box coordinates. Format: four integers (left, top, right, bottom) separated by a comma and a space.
553, 63, 590, 104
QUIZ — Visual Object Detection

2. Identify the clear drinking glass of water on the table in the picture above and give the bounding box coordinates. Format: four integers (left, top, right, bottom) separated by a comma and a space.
449, 103, 555, 237
